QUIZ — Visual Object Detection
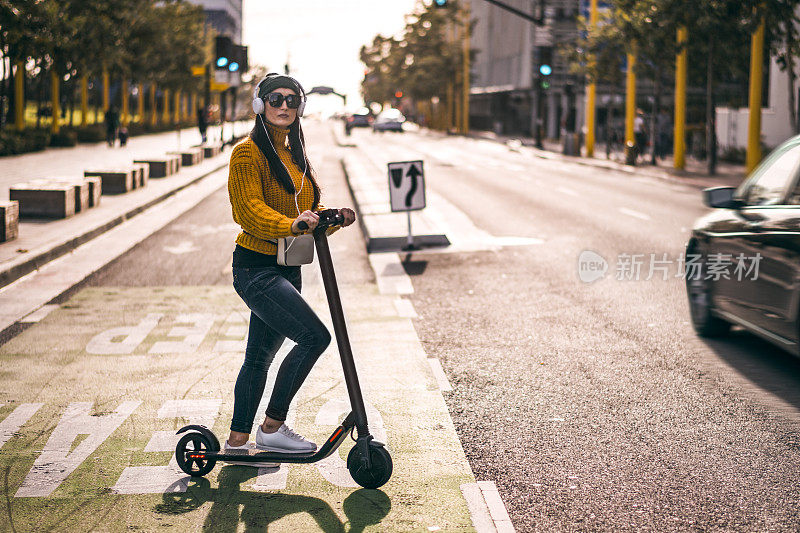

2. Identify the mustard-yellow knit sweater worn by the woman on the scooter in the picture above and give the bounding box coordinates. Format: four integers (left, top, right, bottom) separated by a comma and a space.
228, 124, 323, 255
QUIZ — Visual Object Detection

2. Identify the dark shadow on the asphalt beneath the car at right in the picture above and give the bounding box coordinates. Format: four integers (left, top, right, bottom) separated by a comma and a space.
704, 330, 800, 409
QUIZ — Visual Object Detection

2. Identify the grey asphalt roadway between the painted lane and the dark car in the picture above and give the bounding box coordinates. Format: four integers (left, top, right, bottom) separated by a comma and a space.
352, 125, 800, 531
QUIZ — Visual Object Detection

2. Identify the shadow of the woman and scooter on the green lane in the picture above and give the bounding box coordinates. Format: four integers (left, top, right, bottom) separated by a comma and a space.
155, 466, 392, 533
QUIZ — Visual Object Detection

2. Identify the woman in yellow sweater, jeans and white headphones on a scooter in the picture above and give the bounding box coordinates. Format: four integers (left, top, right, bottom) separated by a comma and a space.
225, 74, 355, 466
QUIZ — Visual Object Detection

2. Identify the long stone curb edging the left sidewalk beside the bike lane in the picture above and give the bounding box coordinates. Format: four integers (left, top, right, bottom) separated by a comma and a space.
0, 154, 234, 288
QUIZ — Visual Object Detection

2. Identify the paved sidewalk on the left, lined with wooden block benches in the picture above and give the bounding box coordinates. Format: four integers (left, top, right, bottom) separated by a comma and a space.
0, 122, 249, 290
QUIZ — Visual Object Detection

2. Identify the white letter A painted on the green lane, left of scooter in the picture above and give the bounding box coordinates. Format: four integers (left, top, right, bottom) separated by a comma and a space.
16, 401, 142, 498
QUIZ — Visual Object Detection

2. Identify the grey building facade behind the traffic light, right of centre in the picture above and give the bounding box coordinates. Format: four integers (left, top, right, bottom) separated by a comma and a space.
470, 0, 585, 139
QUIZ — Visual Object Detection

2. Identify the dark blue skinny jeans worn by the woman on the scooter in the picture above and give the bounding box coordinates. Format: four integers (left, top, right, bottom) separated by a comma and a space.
231, 265, 331, 433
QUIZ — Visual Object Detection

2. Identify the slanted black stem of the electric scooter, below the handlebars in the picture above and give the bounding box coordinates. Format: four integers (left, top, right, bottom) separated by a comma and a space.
314, 228, 369, 437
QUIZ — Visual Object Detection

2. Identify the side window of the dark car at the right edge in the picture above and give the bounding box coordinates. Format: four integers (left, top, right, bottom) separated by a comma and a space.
742, 145, 800, 205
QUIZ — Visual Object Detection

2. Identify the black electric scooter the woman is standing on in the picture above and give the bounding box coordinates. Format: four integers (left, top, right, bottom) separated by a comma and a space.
175, 209, 392, 489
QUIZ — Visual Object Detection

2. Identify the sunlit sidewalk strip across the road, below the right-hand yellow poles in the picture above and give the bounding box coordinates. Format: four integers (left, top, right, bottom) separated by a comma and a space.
466, 130, 747, 189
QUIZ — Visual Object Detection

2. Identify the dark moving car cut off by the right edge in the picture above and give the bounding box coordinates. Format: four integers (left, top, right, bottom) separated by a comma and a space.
685, 136, 800, 355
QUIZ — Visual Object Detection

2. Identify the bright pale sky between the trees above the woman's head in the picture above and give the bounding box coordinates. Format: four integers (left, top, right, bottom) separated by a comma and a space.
242, 0, 417, 112
